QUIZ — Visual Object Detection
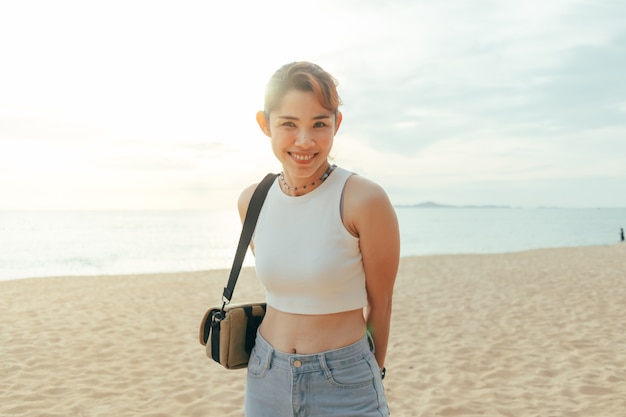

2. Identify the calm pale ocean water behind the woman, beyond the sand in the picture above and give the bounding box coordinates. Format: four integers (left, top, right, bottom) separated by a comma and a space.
0, 207, 626, 280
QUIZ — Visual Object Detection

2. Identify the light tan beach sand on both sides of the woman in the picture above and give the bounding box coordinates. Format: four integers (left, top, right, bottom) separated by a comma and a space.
0, 244, 626, 417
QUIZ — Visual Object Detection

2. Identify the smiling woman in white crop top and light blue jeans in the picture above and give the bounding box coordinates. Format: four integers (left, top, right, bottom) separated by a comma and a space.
238, 62, 400, 417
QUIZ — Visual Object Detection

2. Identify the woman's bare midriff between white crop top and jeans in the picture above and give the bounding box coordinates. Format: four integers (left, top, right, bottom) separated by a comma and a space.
260, 306, 366, 355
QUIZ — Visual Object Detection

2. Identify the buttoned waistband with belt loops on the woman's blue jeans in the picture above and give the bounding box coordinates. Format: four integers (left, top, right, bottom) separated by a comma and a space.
254, 332, 374, 373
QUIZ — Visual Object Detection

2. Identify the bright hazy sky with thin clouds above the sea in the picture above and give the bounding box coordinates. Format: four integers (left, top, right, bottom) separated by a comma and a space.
0, 0, 626, 210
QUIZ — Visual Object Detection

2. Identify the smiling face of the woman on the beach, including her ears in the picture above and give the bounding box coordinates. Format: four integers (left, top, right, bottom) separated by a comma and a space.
257, 90, 341, 186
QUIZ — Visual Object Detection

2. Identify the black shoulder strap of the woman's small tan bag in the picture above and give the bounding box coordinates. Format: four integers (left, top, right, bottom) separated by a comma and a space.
222, 173, 278, 310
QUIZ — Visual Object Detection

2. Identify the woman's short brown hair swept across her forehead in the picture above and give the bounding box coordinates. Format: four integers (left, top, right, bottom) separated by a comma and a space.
263, 61, 341, 119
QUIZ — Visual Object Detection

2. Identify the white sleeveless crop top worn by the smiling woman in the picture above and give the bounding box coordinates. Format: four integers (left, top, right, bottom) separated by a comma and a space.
254, 168, 367, 314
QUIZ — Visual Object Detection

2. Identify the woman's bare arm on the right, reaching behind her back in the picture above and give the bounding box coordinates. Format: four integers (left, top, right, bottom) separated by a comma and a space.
344, 176, 400, 368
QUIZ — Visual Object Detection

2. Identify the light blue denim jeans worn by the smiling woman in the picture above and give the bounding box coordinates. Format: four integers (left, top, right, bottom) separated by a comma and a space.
244, 333, 389, 417
